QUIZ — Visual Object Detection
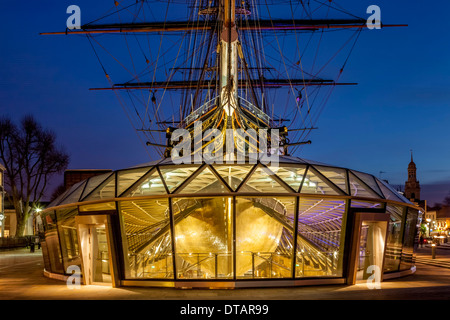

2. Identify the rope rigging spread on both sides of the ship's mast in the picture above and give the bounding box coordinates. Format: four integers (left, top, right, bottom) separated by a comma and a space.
73, 0, 370, 159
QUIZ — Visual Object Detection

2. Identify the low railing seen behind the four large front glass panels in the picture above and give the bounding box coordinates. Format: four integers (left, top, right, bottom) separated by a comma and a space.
130, 251, 338, 279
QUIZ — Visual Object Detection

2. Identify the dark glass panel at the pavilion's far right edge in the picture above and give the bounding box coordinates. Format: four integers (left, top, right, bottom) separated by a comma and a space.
400, 208, 419, 271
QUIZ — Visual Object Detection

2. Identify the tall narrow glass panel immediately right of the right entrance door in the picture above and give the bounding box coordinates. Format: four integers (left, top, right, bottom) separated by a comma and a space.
384, 205, 406, 272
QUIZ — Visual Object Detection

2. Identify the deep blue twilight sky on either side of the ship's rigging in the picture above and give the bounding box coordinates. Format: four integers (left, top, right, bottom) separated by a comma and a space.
0, 0, 450, 204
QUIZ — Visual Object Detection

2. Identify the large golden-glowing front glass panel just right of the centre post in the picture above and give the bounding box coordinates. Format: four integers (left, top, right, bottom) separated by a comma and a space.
236, 197, 296, 279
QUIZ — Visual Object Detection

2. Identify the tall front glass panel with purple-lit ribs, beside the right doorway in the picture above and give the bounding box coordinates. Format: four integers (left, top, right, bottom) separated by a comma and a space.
295, 198, 346, 277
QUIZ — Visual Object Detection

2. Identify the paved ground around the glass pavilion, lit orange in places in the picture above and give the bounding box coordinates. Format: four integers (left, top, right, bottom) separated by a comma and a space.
0, 248, 450, 300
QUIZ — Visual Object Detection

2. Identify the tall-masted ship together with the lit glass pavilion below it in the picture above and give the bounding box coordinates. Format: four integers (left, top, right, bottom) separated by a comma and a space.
38, 0, 418, 288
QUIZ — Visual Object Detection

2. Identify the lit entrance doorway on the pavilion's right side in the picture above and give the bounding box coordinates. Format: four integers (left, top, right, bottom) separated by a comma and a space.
356, 221, 387, 280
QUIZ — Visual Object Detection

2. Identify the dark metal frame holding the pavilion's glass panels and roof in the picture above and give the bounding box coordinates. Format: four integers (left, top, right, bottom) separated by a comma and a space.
43, 157, 418, 288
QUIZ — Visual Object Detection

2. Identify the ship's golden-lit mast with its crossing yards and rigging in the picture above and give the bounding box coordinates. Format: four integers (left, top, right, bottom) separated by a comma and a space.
41, 0, 406, 159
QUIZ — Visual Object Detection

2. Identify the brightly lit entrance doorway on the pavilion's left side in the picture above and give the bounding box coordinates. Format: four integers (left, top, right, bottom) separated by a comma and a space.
76, 216, 114, 285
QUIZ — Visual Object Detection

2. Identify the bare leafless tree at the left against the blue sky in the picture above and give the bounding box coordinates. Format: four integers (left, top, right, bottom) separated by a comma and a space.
0, 116, 69, 236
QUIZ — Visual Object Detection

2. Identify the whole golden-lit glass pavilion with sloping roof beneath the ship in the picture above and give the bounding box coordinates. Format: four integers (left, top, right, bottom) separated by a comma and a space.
42, 156, 419, 288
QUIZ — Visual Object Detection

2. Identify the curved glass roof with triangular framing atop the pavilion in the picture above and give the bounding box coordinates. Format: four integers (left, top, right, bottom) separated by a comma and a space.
48, 156, 412, 208
